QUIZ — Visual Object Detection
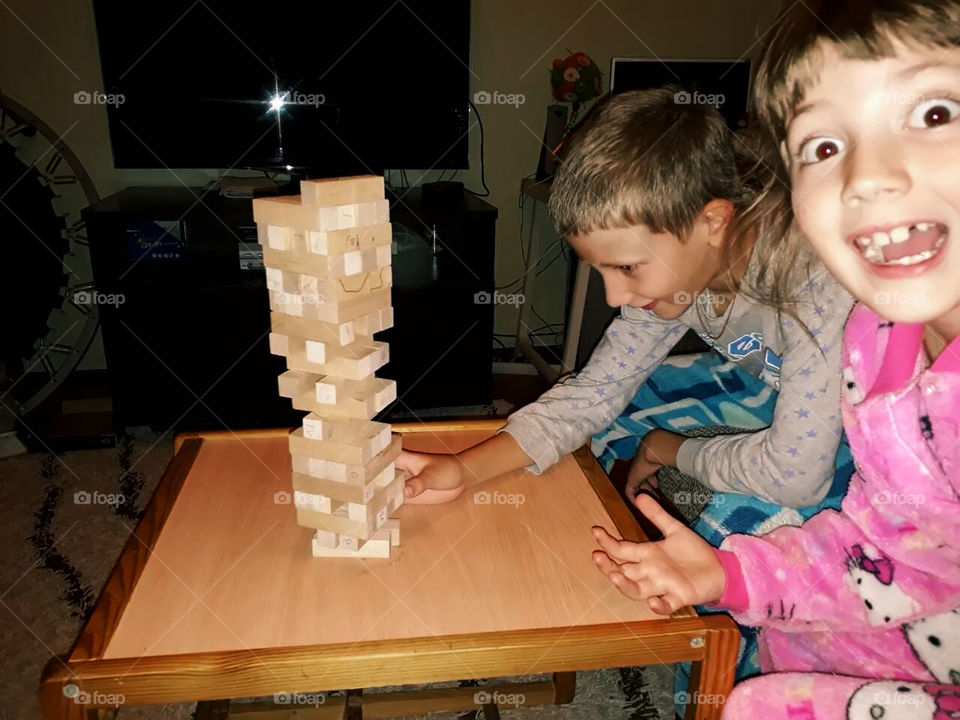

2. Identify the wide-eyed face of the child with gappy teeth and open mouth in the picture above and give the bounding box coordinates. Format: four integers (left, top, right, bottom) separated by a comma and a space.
782, 40, 960, 325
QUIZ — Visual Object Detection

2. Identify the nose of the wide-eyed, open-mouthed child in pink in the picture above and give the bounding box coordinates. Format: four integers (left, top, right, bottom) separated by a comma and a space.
843, 137, 911, 205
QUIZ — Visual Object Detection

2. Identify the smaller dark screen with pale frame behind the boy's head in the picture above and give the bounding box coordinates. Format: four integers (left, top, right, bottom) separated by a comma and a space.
610, 58, 750, 130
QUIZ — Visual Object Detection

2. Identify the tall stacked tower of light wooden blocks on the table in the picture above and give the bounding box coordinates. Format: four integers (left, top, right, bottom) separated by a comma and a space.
253, 175, 404, 557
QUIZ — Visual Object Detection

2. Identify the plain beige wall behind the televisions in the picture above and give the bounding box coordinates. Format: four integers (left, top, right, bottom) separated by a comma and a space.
0, 0, 778, 367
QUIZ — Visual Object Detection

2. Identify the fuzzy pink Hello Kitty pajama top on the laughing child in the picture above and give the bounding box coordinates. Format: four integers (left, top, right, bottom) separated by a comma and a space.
718, 305, 960, 683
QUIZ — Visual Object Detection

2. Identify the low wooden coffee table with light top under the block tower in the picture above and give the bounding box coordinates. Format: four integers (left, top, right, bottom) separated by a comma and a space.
41, 421, 739, 720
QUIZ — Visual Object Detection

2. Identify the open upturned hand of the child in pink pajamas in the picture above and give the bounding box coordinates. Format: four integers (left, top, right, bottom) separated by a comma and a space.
593, 495, 726, 615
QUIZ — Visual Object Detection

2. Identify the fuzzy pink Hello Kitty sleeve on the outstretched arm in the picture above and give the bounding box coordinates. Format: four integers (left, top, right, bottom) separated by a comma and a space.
719, 510, 960, 632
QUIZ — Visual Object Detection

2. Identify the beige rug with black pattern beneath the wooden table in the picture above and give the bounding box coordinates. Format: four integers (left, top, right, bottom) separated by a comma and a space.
0, 436, 674, 720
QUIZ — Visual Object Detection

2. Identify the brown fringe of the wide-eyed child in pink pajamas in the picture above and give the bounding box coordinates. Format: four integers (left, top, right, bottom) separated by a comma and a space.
754, 0, 960, 146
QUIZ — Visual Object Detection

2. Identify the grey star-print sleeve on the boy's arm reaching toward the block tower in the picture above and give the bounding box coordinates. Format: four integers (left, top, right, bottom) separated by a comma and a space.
501, 306, 686, 475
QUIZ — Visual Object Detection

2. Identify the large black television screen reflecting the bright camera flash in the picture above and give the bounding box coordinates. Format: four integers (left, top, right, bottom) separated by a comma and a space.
92, 0, 470, 175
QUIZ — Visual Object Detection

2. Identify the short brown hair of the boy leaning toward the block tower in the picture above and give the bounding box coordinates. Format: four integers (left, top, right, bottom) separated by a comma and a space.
550, 86, 748, 240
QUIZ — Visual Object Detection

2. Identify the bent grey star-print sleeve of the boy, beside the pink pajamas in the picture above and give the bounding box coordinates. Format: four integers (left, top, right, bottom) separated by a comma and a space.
677, 271, 853, 507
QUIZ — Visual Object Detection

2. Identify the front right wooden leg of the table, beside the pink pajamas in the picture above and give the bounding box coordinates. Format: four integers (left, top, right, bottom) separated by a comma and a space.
686, 615, 740, 720
